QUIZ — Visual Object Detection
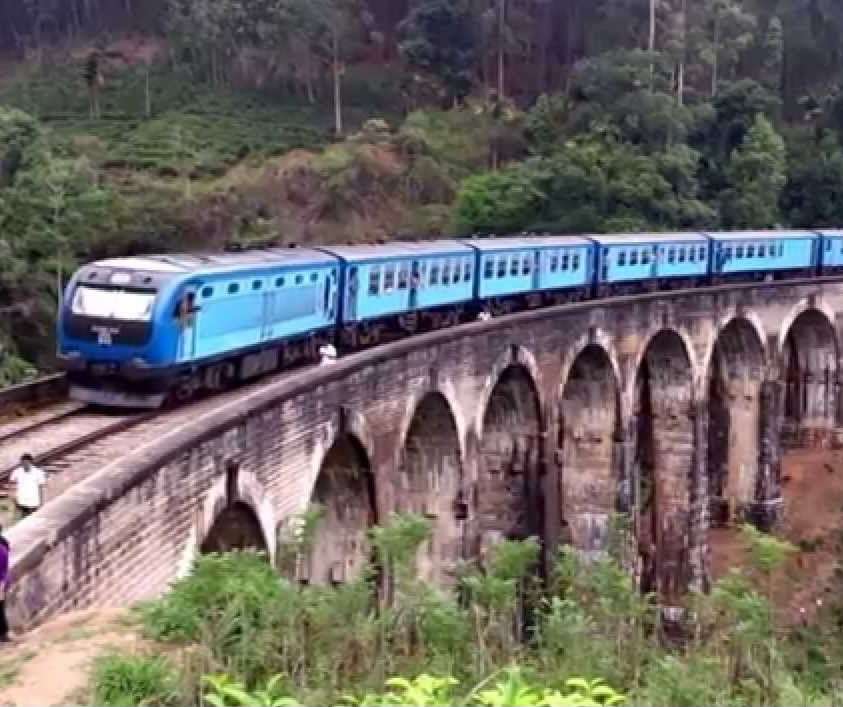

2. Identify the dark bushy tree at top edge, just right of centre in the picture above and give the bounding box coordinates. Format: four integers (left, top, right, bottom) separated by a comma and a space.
399, 0, 477, 101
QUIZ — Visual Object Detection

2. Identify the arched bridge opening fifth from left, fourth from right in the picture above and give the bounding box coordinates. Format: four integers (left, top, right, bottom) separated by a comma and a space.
558, 345, 628, 554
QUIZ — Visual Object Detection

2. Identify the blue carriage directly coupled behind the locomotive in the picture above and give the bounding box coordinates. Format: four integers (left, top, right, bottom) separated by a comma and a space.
320, 240, 475, 348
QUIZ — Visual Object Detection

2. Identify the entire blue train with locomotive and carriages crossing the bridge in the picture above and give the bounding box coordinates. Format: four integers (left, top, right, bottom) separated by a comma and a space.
57, 230, 843, 409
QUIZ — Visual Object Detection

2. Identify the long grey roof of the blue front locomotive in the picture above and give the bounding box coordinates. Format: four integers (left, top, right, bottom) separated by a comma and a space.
93, 248, 336, 275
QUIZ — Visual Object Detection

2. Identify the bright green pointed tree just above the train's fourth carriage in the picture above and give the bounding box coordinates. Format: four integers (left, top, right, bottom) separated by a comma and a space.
721, 115, 786, 228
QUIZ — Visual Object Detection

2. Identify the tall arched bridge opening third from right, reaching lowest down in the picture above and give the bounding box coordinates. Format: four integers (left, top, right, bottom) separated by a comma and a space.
633, 330, 694, 602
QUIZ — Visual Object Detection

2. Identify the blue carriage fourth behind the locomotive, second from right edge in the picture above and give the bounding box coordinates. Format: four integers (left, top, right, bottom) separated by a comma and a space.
707, 231, 821, 284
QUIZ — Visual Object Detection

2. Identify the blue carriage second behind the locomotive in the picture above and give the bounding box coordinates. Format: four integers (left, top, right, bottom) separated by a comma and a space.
464, 236, 593, 314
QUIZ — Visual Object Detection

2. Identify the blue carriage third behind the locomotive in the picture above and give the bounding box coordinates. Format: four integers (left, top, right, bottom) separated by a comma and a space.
589, 233, 710, 297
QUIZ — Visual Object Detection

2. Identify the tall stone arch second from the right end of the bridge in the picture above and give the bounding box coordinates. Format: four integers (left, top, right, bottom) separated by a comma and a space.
706, 317, 766, 525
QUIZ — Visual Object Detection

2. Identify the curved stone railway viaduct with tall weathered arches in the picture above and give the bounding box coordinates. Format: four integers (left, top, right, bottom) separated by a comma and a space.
9, 279, 843, 627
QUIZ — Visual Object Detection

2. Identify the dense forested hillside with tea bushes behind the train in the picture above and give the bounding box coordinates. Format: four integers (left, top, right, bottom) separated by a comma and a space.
0, 0, 843, 384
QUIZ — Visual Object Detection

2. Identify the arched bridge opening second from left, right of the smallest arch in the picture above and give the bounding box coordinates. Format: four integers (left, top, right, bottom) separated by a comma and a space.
302, 435, 375, 584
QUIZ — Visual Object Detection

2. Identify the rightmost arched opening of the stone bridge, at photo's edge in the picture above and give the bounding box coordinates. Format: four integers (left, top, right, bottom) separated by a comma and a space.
782, 309, 837, 446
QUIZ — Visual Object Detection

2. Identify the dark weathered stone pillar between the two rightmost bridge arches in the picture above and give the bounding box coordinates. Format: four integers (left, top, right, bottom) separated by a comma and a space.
750, 381, 784, 530
